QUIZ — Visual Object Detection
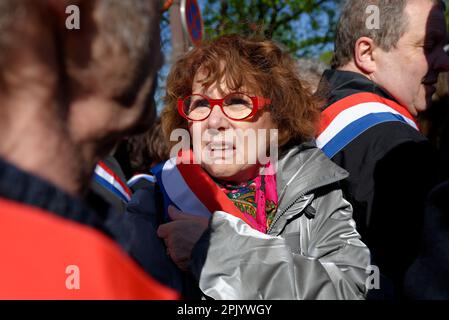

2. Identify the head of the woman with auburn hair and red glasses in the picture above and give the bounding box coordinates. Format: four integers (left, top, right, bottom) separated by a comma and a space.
162, 35, 319, 181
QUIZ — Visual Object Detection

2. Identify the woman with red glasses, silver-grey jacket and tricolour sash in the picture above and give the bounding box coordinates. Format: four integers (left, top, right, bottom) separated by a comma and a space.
127, 35, 370, 299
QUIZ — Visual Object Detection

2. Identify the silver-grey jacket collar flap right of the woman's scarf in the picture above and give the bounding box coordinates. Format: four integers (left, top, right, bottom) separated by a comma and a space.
276, 143, 349, 211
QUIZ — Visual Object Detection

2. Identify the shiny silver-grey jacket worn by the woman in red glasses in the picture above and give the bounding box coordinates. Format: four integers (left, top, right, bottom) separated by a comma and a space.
191, 145, 370, 299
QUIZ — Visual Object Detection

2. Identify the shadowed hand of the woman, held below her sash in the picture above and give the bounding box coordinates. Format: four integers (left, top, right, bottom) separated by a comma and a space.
157, 206, 209, 271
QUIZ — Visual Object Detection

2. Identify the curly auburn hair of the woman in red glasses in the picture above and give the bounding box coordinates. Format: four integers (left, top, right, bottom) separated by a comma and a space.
161, 35, 320, 149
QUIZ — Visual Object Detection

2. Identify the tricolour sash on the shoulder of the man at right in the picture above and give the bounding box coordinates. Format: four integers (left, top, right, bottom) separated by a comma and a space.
316, 92, 419, 158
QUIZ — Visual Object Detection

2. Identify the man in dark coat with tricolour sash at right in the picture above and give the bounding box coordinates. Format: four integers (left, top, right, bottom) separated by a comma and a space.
317, 0, 449, 298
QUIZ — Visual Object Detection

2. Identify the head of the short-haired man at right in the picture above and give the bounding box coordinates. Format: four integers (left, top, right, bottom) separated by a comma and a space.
332, 0, 449, 116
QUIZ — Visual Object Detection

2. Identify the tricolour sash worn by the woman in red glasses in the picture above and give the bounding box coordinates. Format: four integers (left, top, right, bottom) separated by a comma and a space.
151, 152, 251, 226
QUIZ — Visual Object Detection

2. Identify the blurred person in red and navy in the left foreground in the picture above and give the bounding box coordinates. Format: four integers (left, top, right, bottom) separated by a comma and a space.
0, 0, 177, 299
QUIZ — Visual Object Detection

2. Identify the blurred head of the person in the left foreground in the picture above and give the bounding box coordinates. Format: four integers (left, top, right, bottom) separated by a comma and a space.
0, 0, 161, 192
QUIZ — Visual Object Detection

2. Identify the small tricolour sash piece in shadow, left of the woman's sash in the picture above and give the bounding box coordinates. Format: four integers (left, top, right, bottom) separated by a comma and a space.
94, 161, 131, 203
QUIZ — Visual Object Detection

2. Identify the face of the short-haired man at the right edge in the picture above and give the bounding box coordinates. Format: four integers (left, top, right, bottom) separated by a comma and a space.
370, 0, 449, 116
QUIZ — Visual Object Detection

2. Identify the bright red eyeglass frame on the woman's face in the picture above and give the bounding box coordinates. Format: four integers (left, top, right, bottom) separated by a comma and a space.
178, 92, 271, 121
